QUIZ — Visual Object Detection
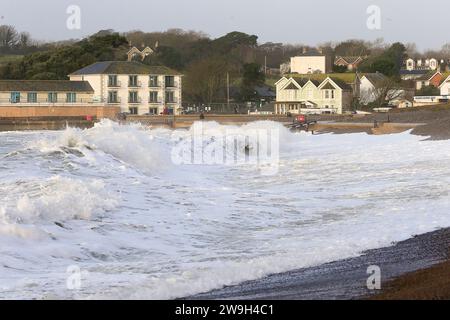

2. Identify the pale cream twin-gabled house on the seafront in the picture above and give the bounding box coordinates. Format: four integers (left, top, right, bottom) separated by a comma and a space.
275, 76, 353, 114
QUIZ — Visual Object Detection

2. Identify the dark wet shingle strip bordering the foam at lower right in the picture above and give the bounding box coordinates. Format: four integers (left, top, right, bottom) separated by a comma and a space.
187, 229, 450, 300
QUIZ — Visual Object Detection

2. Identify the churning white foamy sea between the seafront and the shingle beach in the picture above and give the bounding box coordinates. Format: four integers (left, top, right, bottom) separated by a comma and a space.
0, 121, 450, 299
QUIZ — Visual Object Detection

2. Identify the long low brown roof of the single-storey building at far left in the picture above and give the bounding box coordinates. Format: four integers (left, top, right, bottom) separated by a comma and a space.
0, 80, 94, 93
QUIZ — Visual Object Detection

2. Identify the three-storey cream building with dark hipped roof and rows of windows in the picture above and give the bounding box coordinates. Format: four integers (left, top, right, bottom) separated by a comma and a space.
69, 61, 182, 115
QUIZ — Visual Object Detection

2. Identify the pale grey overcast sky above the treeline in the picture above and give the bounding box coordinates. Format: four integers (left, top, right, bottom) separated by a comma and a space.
0, 0, 450, 50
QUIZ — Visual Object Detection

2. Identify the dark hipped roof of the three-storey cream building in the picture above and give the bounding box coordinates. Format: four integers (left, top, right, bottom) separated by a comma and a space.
70, 61, 181, 75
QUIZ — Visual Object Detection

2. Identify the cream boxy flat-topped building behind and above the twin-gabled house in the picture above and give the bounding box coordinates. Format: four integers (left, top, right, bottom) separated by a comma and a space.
290, 50, 333, 74
